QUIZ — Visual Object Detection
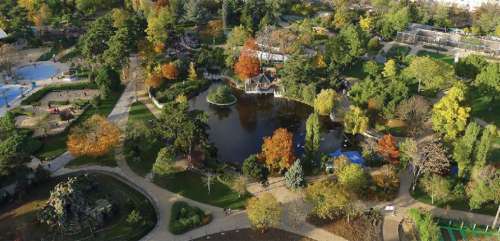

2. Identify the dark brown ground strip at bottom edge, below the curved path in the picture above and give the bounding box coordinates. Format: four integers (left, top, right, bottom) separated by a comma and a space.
195, 229, 314, 241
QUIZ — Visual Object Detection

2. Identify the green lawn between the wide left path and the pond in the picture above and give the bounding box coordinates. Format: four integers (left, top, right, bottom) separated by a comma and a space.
125, 102, 162, 176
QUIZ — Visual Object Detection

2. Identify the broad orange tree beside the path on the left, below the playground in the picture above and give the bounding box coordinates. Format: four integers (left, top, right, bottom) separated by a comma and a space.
67, 115, 120, 157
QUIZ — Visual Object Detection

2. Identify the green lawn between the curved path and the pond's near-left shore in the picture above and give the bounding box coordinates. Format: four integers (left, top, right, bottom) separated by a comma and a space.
154, 171, 248, 209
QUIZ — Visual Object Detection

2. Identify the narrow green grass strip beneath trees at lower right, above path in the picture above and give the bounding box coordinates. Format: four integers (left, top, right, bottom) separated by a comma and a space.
411, 186, 498, 215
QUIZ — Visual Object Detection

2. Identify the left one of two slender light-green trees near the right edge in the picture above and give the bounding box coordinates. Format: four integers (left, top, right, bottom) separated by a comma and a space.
453, 121, 481, 177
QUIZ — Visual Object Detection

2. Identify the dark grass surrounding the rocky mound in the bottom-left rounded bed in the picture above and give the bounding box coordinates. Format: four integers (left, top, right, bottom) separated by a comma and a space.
0, 174, 157, 241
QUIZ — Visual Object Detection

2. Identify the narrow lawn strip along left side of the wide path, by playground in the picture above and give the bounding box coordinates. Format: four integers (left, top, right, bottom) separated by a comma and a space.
35, 91, 122, 161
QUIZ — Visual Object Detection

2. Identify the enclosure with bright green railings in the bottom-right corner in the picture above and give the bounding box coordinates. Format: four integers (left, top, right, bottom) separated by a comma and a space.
437, 218, 500, 241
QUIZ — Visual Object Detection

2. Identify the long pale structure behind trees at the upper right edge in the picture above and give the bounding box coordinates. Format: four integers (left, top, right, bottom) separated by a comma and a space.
396, 23, 500, 56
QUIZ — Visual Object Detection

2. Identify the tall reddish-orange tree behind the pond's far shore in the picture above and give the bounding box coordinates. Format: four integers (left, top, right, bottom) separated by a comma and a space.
234, 38, 260, 79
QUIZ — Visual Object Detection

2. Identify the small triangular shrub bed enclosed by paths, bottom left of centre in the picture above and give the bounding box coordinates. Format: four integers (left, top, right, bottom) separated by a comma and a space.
168, 201, 212, 234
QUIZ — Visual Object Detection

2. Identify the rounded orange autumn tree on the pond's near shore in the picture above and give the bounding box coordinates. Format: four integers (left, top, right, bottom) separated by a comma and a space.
260, 128, 296, 171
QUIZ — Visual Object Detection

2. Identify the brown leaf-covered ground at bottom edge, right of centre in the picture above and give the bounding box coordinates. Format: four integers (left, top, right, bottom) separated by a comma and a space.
307, 215, 383, 241
